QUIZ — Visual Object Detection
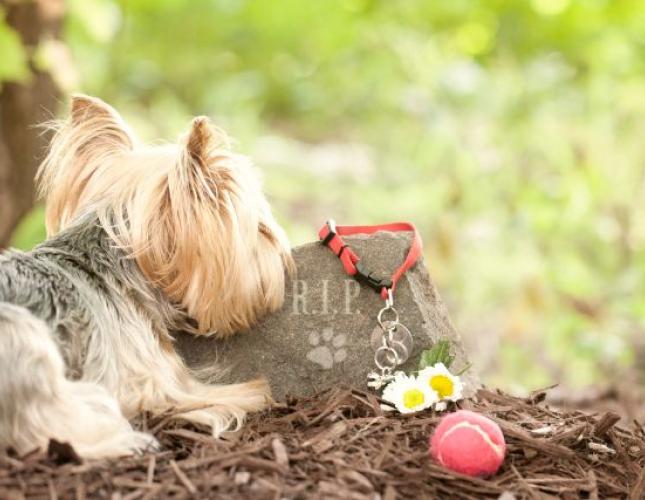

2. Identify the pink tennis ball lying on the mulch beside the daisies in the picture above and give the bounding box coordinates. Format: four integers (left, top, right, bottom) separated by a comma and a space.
430, 410, 506, 476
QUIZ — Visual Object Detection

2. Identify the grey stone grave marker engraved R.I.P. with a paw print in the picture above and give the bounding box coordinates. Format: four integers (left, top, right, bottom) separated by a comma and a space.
177, 232, 476, 400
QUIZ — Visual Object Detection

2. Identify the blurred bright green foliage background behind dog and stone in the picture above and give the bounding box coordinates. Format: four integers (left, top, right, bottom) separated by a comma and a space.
0, 0, 645, 390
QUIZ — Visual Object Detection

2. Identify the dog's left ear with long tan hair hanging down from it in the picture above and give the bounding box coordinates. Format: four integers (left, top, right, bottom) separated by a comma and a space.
37, 95, 134, 235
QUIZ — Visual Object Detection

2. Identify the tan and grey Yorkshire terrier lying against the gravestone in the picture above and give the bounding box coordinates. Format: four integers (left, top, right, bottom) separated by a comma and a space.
0, 96, 293, 458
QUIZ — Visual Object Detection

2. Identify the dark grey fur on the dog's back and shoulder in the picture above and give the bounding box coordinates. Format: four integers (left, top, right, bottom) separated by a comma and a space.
0, 216, 187, 378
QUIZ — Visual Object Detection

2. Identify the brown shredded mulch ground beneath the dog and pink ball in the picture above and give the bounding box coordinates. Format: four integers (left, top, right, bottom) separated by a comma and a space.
0, 389, 645, 500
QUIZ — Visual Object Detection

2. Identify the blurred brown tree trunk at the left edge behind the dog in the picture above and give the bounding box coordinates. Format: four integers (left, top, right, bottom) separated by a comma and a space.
0, 0, 63, 249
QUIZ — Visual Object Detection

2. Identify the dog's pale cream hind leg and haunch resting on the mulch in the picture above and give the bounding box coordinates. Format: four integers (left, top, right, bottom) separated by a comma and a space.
0, 302, 156, 458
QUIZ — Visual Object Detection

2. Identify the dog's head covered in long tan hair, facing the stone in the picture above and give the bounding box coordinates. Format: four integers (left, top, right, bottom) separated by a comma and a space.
39, 96, 292, 335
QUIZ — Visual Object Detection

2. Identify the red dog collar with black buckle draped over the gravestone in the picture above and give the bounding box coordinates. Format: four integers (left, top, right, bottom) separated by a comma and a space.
318, 219, 422, 301
